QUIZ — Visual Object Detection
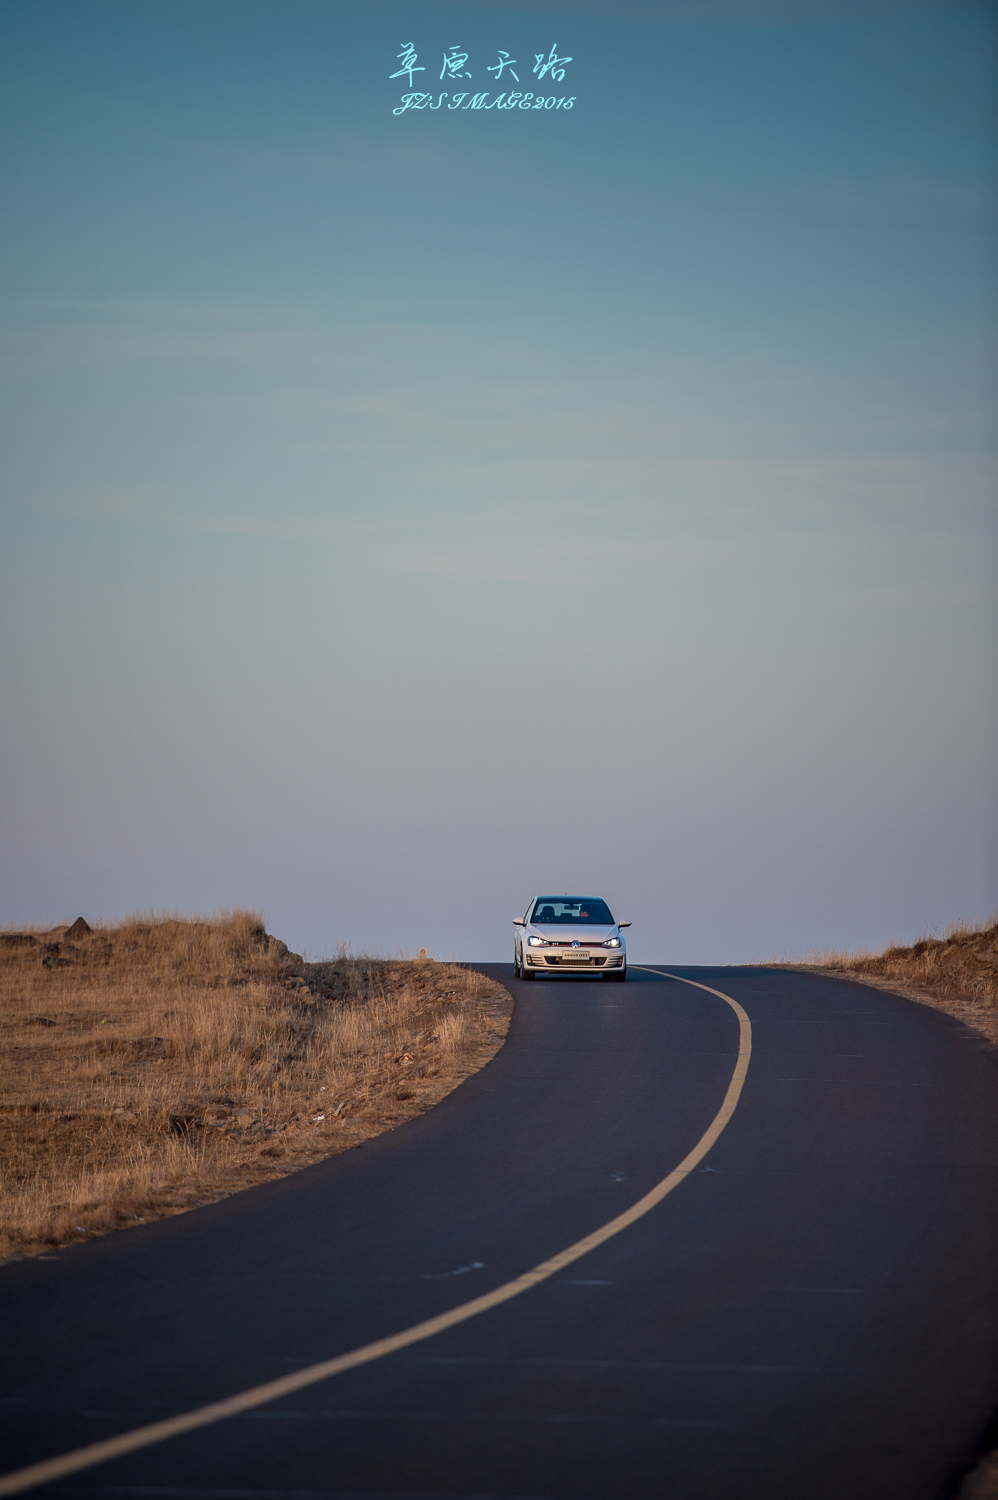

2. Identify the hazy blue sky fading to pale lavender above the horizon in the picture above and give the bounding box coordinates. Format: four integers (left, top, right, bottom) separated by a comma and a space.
0, 0, 998, 963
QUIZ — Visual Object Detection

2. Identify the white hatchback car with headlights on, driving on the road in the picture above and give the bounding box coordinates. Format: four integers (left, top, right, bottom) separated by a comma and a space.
513, 896, 630, 983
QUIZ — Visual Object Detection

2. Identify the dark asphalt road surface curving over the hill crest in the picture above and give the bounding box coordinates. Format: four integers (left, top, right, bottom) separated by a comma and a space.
0, 965, 998, 1500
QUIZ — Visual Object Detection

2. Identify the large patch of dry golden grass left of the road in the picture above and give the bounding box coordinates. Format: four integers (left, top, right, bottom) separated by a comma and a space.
0, 912, 512, 1259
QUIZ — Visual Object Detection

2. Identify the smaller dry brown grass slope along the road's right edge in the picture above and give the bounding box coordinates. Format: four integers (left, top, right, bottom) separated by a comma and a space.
780, 915, 998, 1043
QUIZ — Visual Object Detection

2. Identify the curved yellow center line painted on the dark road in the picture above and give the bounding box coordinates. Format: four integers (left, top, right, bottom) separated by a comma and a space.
0, 965, 752, 1496
